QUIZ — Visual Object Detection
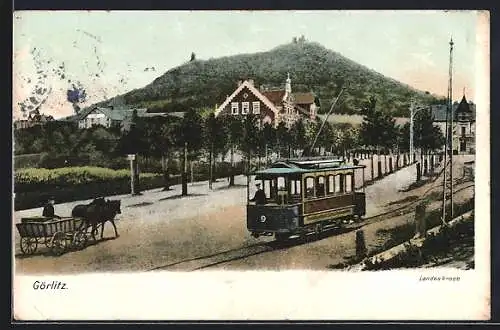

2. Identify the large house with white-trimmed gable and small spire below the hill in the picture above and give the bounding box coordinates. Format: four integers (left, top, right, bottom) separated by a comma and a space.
215, 74, 319, 127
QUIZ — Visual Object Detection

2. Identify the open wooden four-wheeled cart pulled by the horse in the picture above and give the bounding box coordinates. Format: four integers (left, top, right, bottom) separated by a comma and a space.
16, 217, 88, 255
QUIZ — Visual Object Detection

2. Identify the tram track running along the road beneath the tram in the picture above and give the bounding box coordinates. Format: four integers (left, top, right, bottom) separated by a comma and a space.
147, 163, 474, 271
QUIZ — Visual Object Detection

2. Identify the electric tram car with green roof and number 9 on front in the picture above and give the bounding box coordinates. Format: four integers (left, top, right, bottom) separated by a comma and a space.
246, 159, 366, 241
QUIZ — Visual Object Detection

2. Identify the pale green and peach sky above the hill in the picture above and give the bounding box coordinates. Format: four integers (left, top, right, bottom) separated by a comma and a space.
13, 10, 478, 118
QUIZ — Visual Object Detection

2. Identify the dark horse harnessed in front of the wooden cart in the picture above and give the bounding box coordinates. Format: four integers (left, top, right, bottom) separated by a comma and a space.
71, 197, 121, 240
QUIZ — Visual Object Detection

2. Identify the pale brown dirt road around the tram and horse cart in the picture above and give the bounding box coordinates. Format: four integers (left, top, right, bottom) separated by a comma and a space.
14, 156, 471, 274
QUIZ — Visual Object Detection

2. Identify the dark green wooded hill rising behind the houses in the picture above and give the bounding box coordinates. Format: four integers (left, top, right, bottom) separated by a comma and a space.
97, 40, 446, 116
